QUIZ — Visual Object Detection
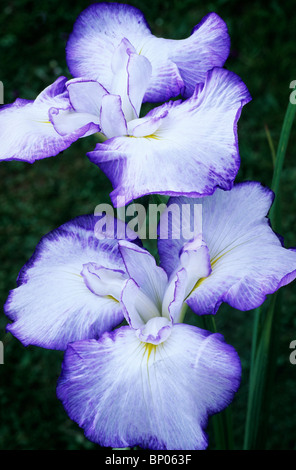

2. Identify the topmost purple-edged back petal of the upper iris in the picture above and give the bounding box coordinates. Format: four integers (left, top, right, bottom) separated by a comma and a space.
66, 3, 230, 102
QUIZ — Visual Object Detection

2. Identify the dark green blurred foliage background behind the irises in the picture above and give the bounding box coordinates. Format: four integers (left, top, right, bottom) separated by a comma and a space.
0, 0, 296, 450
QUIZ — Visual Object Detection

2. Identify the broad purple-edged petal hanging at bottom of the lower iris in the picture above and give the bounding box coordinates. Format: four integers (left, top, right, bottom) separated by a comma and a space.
57, 324, 241, 450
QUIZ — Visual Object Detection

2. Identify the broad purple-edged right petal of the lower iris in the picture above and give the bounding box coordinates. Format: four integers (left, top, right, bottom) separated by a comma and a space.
158, 182, 296, 315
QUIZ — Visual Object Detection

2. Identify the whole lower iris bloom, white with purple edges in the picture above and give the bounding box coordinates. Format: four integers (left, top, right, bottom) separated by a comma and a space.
5, 183, 296, 450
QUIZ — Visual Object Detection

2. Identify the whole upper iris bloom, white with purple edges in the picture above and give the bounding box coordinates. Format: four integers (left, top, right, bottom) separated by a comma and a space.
0, 4, 250, 207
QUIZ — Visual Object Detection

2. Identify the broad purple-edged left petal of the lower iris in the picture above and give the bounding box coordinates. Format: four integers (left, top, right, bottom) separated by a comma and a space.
5, 216, 139, 349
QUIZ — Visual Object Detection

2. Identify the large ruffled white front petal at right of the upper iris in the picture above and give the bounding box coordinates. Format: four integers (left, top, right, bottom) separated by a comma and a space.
88, 68, 250, 206
